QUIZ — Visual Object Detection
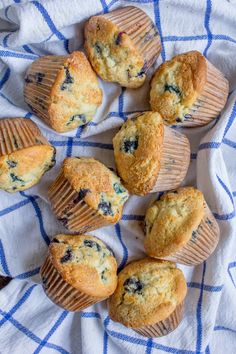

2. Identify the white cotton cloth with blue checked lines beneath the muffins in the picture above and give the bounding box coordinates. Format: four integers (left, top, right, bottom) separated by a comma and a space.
0, 0, 236, 354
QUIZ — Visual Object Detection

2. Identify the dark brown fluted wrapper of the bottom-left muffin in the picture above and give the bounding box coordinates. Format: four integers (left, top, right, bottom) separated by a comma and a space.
40, 255, 105, 311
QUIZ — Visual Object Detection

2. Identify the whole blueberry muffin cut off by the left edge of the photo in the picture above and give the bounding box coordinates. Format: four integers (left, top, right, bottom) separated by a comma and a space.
0, 118, 56, 193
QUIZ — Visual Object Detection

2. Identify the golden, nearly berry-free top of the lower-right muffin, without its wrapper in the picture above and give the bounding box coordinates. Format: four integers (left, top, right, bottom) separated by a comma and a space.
144, 187, 205, 257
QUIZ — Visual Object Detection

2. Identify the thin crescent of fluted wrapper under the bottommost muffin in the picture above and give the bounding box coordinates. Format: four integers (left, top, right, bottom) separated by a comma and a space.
133, 302, 184, 338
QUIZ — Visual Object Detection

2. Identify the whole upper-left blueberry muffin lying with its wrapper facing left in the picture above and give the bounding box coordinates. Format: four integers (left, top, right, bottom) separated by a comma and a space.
24, 52, 102, 133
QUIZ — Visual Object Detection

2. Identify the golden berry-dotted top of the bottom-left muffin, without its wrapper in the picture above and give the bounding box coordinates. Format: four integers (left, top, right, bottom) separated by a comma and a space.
49, 235, 117, 298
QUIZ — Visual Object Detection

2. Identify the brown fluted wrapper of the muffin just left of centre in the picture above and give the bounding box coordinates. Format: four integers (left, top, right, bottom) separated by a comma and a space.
49, 172, 109, 234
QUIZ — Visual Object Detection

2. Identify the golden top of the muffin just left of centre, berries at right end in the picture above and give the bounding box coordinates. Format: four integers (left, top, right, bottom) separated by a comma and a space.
62, 157, 129, 223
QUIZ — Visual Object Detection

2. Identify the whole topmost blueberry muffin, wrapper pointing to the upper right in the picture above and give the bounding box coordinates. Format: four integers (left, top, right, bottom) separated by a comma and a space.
85, 6, 161, 88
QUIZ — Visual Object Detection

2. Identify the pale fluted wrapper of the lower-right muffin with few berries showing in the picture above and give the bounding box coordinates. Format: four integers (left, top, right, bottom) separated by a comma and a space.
158, 204, 220, 265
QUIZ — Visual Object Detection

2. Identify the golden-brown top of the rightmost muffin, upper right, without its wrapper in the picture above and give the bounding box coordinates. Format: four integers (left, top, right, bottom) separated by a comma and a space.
150, 51, 207, 124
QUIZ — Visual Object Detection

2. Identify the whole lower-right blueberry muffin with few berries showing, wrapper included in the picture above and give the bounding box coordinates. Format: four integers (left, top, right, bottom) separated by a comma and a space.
144, 187, 220, 265
